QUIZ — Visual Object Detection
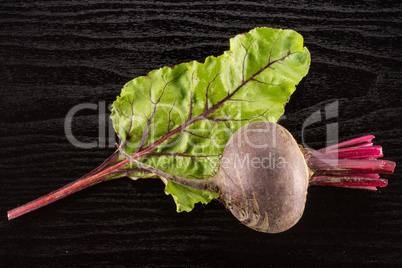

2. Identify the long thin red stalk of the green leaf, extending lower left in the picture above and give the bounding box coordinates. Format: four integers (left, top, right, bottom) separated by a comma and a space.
7, 153, 128, 220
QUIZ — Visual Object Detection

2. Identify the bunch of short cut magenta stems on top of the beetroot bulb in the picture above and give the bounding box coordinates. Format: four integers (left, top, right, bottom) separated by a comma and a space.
308, 135, 396, 191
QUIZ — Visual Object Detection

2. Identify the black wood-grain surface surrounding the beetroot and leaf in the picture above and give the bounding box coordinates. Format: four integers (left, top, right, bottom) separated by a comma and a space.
0, 0, 402, 267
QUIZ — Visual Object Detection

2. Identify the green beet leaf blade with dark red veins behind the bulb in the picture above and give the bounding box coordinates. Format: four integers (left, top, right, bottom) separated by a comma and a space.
111, 28, 310, 211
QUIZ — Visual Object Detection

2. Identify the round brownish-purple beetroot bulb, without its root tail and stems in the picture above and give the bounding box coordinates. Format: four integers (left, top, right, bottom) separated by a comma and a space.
216, 122, 309, 233
